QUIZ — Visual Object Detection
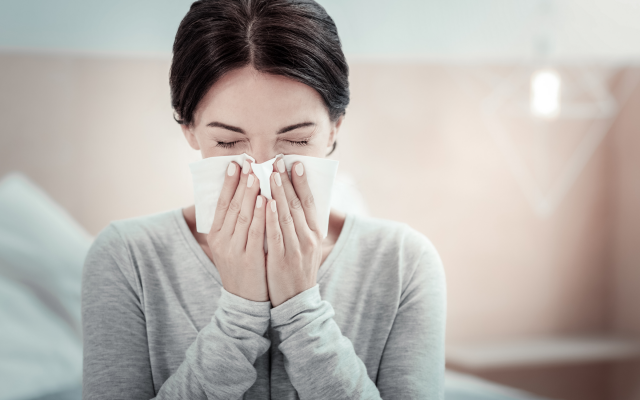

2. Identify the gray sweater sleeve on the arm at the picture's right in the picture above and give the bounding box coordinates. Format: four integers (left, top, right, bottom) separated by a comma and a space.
271, 236, 446, 400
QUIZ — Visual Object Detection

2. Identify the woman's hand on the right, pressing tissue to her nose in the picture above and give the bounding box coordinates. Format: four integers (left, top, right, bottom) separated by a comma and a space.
266, 157, 322, 307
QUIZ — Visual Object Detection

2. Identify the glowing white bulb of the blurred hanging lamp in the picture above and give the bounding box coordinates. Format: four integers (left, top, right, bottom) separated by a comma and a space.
530, 70, 560, 118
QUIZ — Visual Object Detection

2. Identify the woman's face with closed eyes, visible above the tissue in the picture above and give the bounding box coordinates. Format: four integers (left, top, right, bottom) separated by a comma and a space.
181, 66, 342, 163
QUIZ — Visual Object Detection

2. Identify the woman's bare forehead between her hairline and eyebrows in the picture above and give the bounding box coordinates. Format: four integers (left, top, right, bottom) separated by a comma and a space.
195, 66, 329, 126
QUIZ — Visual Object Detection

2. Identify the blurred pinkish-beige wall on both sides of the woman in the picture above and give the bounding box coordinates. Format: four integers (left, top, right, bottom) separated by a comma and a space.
0, 54, 640, 399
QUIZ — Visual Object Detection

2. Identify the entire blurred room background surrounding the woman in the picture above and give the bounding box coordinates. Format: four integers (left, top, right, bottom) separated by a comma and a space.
0, 0, 640, 400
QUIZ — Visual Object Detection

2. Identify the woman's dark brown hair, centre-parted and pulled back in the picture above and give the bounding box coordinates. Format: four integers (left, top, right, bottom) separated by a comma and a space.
169, 0, 349, 153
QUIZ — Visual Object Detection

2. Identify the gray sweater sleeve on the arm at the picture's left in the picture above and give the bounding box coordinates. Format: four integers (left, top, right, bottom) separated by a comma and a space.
82, 224, 271, 399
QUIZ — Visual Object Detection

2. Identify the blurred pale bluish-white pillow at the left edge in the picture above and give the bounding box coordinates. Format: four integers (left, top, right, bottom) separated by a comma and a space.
0, 172, 93, 400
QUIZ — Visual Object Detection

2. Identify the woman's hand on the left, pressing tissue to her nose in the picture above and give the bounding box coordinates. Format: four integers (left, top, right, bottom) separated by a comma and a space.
207, 161, 269, 301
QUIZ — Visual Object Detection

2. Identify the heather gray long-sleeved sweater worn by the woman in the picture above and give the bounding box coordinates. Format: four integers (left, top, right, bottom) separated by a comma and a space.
82, 209, 446, 400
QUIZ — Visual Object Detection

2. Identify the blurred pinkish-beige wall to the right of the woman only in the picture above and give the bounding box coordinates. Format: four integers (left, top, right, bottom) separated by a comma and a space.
339, 65, 609, 341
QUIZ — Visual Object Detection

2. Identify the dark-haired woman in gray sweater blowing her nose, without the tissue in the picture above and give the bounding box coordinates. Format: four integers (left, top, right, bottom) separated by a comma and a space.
82, 0, 445, 399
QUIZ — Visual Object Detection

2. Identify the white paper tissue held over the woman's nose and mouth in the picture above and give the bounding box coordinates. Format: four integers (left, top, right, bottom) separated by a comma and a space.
189, 153, 338, 241
